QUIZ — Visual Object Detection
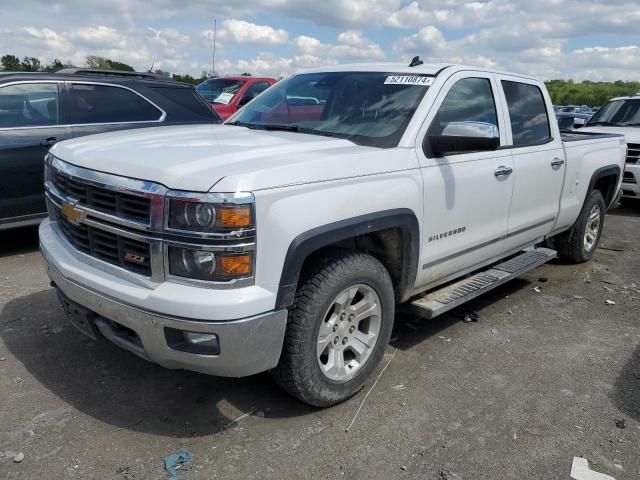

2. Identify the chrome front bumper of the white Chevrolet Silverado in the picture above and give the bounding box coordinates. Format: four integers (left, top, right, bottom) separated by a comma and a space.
41, 222, 287, 377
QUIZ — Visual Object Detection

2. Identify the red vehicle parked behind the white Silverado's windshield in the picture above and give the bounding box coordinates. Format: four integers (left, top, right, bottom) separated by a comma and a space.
196, 76, 277, 120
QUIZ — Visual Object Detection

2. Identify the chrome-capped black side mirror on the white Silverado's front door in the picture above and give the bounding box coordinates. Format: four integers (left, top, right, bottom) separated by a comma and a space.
425, 122, 500, 157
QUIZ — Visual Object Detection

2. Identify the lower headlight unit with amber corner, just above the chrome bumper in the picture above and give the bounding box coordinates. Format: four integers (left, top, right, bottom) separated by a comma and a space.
169, 246, 253, 282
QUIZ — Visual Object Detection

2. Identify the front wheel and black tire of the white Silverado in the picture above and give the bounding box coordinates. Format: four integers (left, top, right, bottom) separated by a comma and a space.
272, 250, 395, 407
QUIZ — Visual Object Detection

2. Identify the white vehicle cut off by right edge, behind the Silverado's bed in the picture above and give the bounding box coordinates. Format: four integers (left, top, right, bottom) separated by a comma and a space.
582, 93, 640, 202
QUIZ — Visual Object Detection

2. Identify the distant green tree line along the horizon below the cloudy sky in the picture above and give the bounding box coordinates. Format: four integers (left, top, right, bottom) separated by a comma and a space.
0, 54, 640, 102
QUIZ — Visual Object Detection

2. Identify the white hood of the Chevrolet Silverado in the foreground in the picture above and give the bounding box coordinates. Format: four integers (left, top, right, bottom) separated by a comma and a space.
51, 125, 380, 192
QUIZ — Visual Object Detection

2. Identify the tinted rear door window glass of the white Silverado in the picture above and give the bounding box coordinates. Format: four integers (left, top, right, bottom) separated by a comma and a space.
502, 80, 551, 147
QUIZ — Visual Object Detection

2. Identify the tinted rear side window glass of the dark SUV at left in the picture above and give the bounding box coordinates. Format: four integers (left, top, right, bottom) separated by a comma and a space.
69, 83, 162, 124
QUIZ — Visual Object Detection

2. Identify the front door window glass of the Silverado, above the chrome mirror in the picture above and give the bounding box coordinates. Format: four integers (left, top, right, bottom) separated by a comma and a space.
429, 78, 498, 135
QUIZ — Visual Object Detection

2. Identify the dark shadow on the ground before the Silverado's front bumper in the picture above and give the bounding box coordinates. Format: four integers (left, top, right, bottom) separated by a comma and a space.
0, 289, 316, 437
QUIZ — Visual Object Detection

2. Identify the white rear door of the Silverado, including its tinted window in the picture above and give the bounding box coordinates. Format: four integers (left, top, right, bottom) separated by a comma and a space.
497, 75, 565, 251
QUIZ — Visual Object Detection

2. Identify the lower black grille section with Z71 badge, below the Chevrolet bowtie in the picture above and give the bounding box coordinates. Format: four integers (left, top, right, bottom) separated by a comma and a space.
49, 203, 151, 277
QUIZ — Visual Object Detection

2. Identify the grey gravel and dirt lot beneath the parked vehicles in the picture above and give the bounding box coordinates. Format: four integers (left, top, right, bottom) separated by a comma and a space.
0, 203, 640, 480
